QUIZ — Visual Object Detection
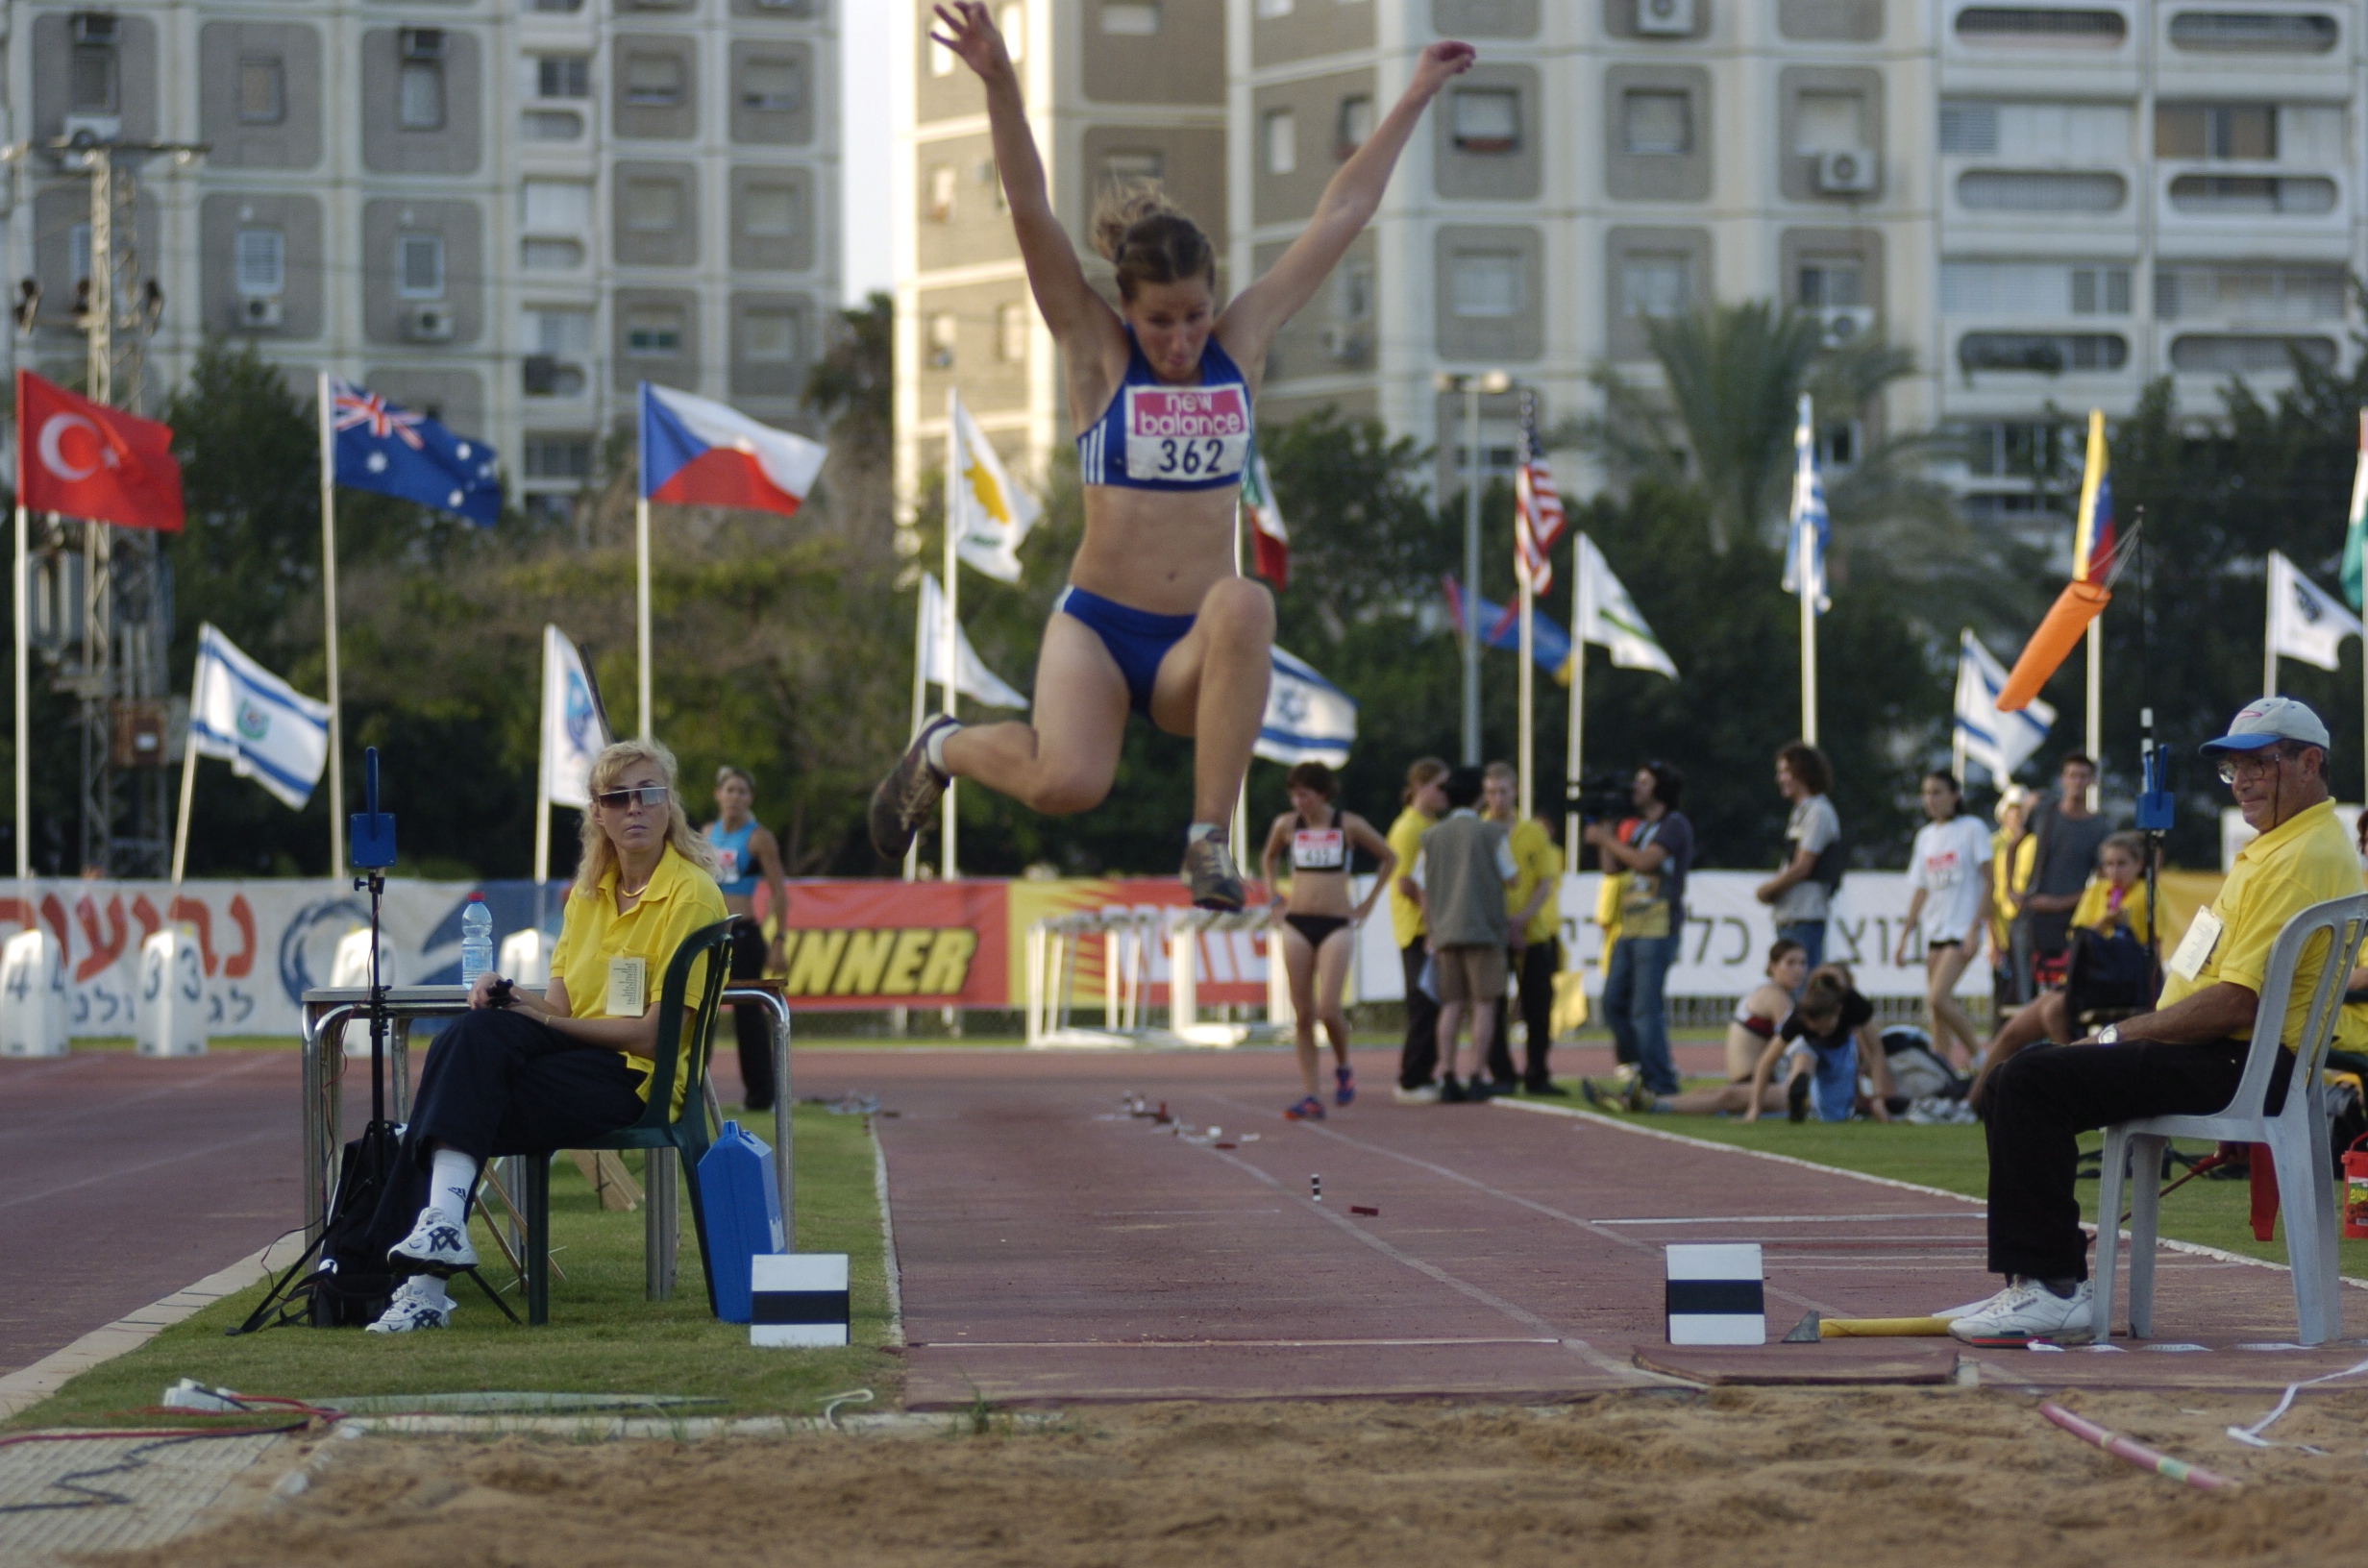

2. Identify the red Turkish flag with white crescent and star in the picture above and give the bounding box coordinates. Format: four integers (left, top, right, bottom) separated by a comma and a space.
16, 370, 183, 533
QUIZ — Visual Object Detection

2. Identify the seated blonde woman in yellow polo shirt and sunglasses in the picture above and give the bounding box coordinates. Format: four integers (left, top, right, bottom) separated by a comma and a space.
369, 742, 727, 1334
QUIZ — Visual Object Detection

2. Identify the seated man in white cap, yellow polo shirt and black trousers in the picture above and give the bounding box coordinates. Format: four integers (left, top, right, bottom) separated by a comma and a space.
1949, 697, 2361, 1345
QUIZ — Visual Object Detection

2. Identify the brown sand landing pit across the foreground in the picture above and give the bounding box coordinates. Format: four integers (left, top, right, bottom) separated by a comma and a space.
120, 1388, 2368, 1568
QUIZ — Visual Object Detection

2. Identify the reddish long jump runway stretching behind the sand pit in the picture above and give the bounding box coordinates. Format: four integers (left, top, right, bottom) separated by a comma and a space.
798, 1049, 2368, 1407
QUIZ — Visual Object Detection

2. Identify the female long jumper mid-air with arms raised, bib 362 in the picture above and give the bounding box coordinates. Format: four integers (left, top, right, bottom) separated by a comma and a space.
872, 0, 1473, 910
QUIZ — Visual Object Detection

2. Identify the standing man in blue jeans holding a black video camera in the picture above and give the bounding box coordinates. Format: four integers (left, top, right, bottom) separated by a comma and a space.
1584, 763, 1693, 1111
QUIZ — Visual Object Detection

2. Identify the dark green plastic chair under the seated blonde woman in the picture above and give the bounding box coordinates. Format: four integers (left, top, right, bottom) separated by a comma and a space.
526, 915, 746, 1324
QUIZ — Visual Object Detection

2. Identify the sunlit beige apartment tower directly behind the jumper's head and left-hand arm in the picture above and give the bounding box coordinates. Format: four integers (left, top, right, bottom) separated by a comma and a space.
883, 0, 1241, 527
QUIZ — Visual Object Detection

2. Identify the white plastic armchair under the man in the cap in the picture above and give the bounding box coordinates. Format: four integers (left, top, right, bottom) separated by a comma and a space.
2093, 895, 2368, 1345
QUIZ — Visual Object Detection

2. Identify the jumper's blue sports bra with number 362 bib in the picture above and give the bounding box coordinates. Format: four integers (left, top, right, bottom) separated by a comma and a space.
1077, 327, 1250, 490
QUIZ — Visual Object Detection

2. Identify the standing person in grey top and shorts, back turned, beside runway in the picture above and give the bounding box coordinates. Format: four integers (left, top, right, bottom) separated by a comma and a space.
1414, 768, 1520, 1104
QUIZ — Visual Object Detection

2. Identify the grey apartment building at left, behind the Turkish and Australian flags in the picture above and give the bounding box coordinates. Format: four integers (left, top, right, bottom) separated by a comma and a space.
7, 0, 838, 507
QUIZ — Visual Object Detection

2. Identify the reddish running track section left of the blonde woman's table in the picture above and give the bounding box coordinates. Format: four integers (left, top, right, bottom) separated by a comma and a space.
0, 1049, 303, 1371
